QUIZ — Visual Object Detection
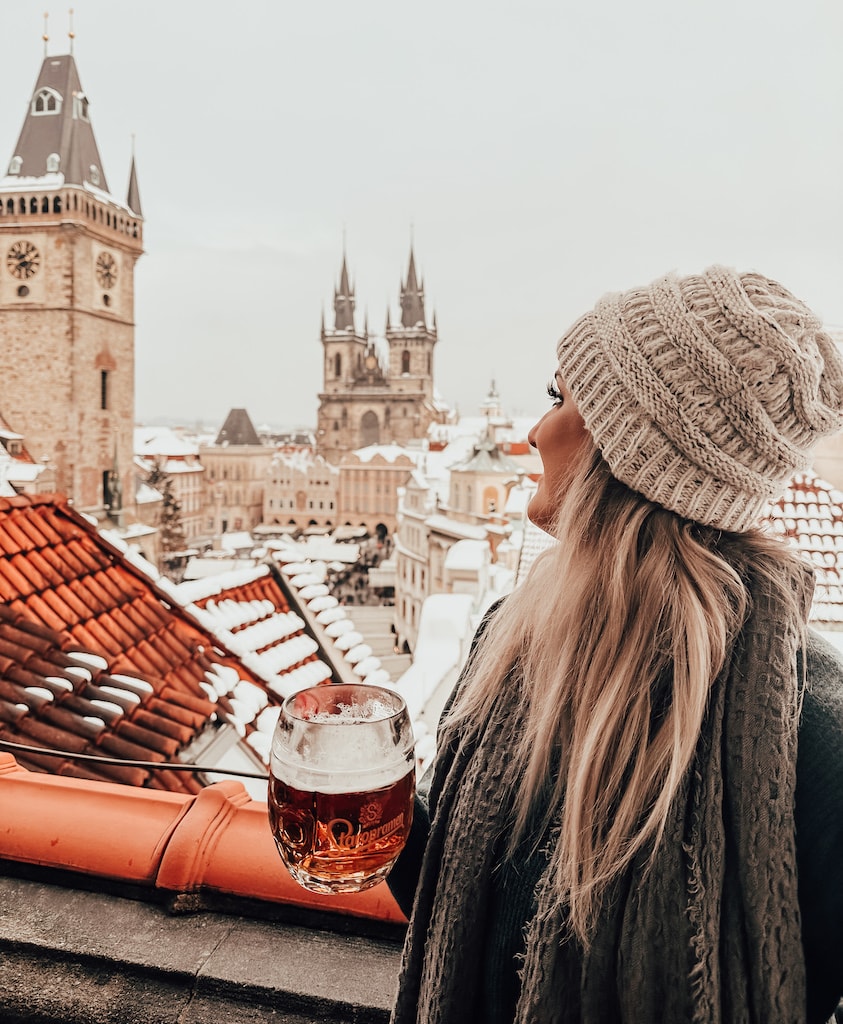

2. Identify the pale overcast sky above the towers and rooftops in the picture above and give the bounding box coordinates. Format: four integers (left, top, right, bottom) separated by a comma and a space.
0, 0, 843, 426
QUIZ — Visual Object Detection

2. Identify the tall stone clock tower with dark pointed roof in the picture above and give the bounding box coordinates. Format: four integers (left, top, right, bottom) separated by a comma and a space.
0, 44, 143, 520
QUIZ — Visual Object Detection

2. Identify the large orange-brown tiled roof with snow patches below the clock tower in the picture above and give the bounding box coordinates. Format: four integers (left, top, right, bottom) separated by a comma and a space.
0, 496, 309, 794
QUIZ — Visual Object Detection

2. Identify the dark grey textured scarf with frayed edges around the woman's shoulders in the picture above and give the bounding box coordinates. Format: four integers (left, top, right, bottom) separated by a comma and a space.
392, 569, 812, 1024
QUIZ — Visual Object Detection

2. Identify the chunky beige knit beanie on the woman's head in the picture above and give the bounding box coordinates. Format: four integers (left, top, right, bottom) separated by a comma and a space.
557, 266, 843, 531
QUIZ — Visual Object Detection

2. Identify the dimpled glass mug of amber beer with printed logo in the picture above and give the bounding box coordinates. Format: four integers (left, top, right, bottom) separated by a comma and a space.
267, 683, 416, 893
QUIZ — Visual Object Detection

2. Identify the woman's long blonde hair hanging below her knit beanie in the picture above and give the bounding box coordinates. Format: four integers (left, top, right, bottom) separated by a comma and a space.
447, 441, 795, 946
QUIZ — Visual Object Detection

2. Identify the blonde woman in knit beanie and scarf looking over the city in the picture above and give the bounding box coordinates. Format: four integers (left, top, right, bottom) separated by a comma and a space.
390, 267, 843, 1024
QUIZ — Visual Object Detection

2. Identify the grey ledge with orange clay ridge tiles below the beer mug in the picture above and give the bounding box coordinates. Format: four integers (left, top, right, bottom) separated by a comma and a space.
0, 754, 406, 1024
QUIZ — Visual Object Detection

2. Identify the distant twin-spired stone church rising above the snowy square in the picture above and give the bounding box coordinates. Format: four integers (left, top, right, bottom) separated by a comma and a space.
317, 249, 448, 464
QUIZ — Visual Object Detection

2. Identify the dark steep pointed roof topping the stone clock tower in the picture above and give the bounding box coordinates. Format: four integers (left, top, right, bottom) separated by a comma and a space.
5, 54, 110, 192
